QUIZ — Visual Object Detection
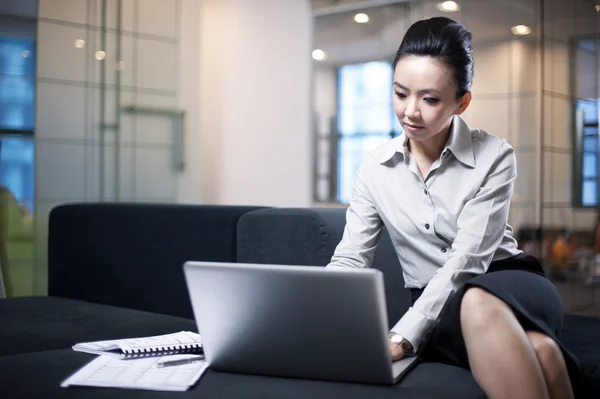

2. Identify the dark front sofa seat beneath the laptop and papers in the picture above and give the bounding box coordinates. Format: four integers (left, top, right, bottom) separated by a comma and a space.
0, 349, 485, 399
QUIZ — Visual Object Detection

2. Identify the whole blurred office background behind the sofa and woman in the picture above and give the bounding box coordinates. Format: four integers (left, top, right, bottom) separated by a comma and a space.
0, 0, 600, 315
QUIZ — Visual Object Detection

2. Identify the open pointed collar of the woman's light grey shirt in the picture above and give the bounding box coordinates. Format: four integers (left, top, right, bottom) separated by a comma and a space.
379, 116, 475, 168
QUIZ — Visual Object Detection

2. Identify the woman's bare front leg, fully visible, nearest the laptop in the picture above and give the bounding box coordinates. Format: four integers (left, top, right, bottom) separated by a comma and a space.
460, 287, 550, 399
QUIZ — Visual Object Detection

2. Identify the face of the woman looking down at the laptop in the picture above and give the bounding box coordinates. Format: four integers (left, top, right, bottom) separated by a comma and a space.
393, 56, 471, 141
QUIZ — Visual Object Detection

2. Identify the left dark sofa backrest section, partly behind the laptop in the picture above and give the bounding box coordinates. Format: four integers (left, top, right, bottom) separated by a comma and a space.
48, 203, 266, 318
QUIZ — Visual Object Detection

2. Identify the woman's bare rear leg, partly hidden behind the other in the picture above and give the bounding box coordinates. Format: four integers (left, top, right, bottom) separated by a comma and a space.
526, 331, 573, 399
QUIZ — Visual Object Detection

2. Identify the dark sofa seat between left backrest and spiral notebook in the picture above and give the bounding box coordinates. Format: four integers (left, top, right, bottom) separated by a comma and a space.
0, 297, 197, 358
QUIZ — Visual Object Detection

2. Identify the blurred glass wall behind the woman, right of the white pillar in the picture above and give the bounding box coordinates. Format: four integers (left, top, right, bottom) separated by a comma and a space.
314, 0, 600, 313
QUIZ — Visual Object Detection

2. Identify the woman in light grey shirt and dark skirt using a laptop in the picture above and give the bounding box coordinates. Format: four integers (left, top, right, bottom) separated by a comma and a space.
328, 17, 579, 399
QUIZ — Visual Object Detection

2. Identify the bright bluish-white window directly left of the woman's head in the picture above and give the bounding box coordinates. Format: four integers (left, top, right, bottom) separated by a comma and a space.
336, 62, 401, 203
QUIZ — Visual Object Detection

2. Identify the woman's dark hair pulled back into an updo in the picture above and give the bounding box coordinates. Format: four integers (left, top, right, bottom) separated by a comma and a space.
393, 17, 473, 98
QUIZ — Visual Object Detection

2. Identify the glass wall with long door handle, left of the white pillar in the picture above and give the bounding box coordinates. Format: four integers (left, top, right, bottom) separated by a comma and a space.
0, 0, 184, 296
